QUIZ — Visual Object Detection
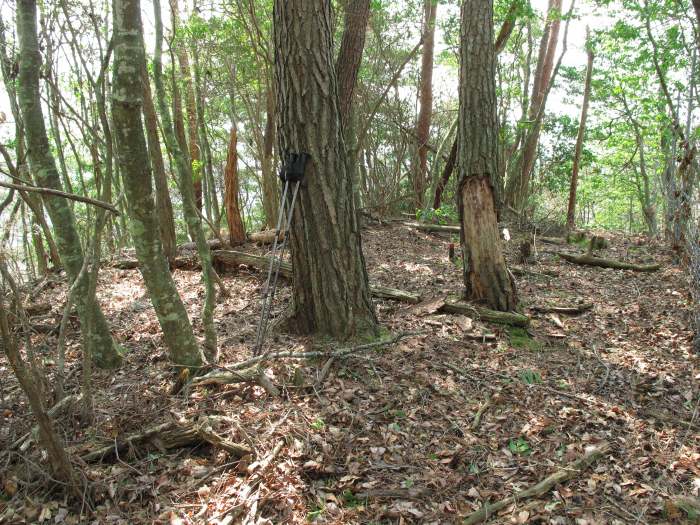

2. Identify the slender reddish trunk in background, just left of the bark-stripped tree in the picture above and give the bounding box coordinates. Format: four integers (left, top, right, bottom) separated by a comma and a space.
413, 0, 437, 209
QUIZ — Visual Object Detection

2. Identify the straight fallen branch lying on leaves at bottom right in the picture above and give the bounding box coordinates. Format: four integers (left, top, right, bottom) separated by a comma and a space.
464, 442, 610, 525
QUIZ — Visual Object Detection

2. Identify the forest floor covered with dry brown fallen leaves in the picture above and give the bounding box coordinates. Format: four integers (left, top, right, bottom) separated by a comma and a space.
0, 219, 700, 525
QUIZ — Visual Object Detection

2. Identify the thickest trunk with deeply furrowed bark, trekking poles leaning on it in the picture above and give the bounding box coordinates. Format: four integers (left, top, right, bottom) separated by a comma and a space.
273, 0, 378, 339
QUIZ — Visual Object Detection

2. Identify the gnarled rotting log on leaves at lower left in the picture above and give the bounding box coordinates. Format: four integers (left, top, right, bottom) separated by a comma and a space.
80, 417, 253, 462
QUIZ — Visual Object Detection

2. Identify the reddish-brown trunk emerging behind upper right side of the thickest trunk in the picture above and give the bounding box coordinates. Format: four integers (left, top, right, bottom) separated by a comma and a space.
335, 0, 370, 126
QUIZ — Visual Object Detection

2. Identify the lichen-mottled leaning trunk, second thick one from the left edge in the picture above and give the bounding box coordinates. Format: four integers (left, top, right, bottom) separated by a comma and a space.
112, 0, 202, 367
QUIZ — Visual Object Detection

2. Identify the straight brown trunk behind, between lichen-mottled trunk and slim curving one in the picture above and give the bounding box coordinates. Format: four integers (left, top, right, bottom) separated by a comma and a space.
143, 60, 177, 263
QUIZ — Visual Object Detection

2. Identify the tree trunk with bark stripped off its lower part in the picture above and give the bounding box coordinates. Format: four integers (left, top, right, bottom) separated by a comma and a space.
457, 0, 517, 311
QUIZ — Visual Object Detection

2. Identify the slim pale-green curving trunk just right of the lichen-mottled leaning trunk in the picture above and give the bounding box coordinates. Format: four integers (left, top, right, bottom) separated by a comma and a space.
154, 0, 218, 363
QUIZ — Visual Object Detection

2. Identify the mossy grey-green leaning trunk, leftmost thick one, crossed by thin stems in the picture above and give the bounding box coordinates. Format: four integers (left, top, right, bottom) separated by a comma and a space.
17, 0, 121, 368
